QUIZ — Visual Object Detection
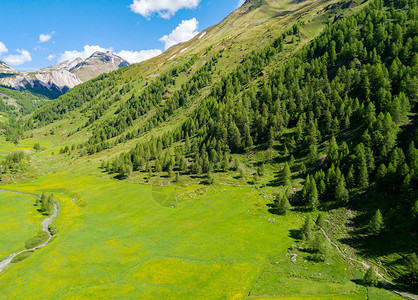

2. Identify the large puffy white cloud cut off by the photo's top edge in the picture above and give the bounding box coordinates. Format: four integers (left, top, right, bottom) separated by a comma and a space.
130, 0, 200, 19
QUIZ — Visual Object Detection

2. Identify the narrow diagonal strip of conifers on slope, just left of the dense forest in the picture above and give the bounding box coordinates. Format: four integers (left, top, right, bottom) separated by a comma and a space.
86, 50, 223, 154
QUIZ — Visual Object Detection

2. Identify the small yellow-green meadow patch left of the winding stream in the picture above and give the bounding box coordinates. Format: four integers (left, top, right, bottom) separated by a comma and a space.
0, 191, 43, 260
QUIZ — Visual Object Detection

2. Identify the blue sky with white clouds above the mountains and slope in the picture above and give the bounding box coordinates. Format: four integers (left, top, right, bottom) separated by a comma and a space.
0, 0, 242, 71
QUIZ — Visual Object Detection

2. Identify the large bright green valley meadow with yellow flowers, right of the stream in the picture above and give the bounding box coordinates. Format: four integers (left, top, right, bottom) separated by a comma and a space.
0, 173, 404, 299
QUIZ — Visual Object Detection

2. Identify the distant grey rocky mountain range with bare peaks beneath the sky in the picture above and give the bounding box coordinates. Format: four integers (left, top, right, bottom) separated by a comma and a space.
0, 52, 129, 96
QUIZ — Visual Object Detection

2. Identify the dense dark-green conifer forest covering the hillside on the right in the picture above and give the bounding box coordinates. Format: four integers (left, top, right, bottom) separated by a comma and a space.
103, 1, 418, 290
